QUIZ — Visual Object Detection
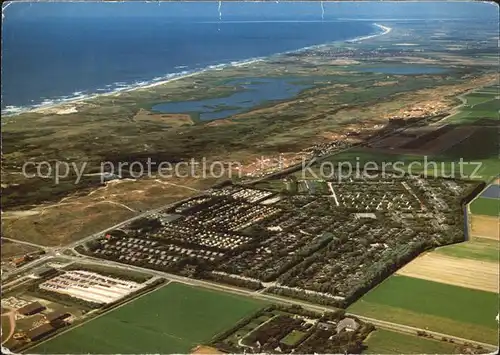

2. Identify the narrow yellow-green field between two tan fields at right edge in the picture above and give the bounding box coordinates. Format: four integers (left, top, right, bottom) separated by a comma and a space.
436, 238, 500, 262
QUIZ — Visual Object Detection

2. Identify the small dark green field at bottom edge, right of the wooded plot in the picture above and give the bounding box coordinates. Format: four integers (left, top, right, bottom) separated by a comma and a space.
363, 329, 459, 354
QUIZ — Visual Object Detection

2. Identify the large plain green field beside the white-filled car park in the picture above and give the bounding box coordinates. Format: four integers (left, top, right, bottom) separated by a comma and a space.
30, 283, 265, 354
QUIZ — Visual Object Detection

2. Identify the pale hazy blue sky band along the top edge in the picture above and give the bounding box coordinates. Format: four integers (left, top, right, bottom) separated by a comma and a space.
3, 1, 498, 21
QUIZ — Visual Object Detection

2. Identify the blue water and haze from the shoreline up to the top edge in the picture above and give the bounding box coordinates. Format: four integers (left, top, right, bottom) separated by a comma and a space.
1, 2, 493, 114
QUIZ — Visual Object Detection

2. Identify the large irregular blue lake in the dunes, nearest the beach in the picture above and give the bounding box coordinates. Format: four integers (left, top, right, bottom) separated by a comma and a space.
152, 77, 312, 121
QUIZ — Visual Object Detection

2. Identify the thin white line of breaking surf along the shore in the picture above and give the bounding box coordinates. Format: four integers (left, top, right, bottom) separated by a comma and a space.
1, 23, 392, 116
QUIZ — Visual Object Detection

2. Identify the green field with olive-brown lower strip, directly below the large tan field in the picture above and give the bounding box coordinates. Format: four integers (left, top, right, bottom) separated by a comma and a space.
348, 275, 498, 344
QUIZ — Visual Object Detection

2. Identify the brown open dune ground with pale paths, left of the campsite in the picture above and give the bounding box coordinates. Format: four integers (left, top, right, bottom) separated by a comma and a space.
2, 178, 214, 246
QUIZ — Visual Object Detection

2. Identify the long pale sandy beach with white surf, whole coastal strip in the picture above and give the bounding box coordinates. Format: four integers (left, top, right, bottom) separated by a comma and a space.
1, 23, 392, 118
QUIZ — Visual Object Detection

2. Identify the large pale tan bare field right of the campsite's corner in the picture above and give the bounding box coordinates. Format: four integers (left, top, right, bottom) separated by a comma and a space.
397, 253, 499, 292
